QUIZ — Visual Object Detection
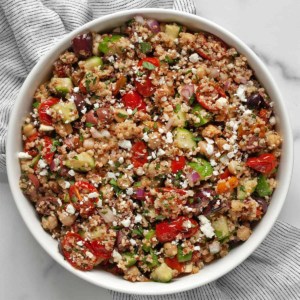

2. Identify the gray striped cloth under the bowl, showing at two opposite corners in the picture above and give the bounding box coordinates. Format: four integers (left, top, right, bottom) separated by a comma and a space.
0, 0, 300, 300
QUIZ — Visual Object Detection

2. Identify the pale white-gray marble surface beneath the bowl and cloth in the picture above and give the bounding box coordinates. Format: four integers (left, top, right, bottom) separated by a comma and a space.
0, 0, 300, 300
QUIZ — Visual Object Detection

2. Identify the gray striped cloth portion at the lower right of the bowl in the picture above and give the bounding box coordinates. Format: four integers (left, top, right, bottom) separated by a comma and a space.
111, 221, 300, 300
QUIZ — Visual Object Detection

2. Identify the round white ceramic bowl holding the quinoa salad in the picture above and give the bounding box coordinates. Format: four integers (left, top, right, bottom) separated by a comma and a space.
6, 9, 293, 295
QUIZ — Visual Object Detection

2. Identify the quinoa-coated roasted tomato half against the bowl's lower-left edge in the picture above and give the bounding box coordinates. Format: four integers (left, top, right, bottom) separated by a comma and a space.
61, 232, 97, 271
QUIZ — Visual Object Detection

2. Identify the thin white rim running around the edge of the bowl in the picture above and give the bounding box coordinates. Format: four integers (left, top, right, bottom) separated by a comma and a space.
6, 8, 293, 295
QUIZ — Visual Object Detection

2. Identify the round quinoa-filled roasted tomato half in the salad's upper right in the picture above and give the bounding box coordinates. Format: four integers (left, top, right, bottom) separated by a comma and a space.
196, 83, 226, 111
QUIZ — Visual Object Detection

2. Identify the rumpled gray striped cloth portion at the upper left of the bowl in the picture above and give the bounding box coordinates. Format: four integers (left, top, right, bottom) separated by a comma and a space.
0, 0, 195, 172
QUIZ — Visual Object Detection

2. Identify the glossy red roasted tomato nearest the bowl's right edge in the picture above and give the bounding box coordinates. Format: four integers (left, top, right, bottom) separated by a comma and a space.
246, 153, 277, 174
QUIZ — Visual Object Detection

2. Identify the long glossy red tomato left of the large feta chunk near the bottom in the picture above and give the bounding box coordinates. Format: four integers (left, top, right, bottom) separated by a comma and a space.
156, 216, 199, 243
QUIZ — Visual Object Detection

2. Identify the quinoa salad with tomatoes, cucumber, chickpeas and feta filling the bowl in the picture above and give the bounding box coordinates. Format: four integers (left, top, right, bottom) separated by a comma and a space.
18, 16, 282, 282
